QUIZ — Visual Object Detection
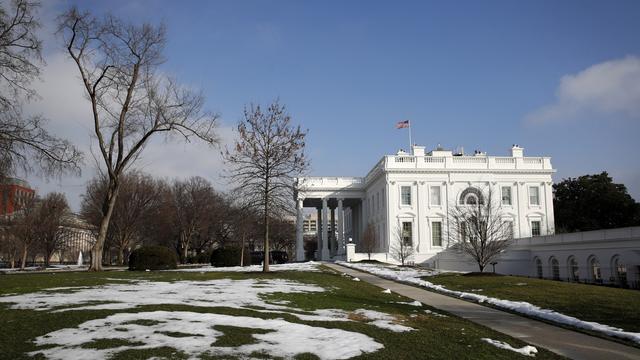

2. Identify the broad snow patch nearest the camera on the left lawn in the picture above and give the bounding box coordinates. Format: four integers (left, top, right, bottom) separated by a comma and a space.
30, 311, 384, 360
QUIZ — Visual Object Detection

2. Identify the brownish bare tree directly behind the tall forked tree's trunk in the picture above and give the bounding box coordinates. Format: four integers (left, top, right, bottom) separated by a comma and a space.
82, 171, 161, 265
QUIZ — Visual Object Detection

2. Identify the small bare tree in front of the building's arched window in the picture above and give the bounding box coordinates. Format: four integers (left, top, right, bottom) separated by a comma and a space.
446, 188, 513, 272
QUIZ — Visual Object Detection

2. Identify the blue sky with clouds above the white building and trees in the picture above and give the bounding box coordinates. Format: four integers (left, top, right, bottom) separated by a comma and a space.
30, 1, 640, 207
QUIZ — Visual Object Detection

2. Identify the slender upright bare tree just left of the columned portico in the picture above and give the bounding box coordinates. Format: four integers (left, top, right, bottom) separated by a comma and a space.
223, 101, 309, 272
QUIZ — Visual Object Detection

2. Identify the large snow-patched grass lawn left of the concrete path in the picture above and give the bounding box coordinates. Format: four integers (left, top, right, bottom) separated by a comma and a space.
0, 270, 561, 359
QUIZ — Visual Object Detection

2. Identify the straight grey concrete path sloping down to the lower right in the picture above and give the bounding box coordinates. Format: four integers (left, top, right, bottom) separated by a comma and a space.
324, 263, 640, 360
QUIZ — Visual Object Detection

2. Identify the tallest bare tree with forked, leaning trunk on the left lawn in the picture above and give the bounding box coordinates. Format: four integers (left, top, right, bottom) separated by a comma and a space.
58, 7, 217, 271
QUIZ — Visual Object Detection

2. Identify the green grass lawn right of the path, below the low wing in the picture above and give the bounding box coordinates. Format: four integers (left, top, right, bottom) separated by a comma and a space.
423, 273, 640, 332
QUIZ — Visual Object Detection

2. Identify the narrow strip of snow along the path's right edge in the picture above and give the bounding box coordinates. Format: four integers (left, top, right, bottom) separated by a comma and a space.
336, 261, 640, 344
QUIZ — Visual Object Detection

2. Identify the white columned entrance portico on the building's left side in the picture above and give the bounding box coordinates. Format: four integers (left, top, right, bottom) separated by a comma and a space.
295, 177, 364, 261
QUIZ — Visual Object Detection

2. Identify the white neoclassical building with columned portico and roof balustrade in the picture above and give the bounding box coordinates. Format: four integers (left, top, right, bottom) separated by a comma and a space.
295, 145, 554, 263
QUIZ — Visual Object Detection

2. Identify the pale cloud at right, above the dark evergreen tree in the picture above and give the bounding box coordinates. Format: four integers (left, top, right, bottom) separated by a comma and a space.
525, 56, 640, 124
